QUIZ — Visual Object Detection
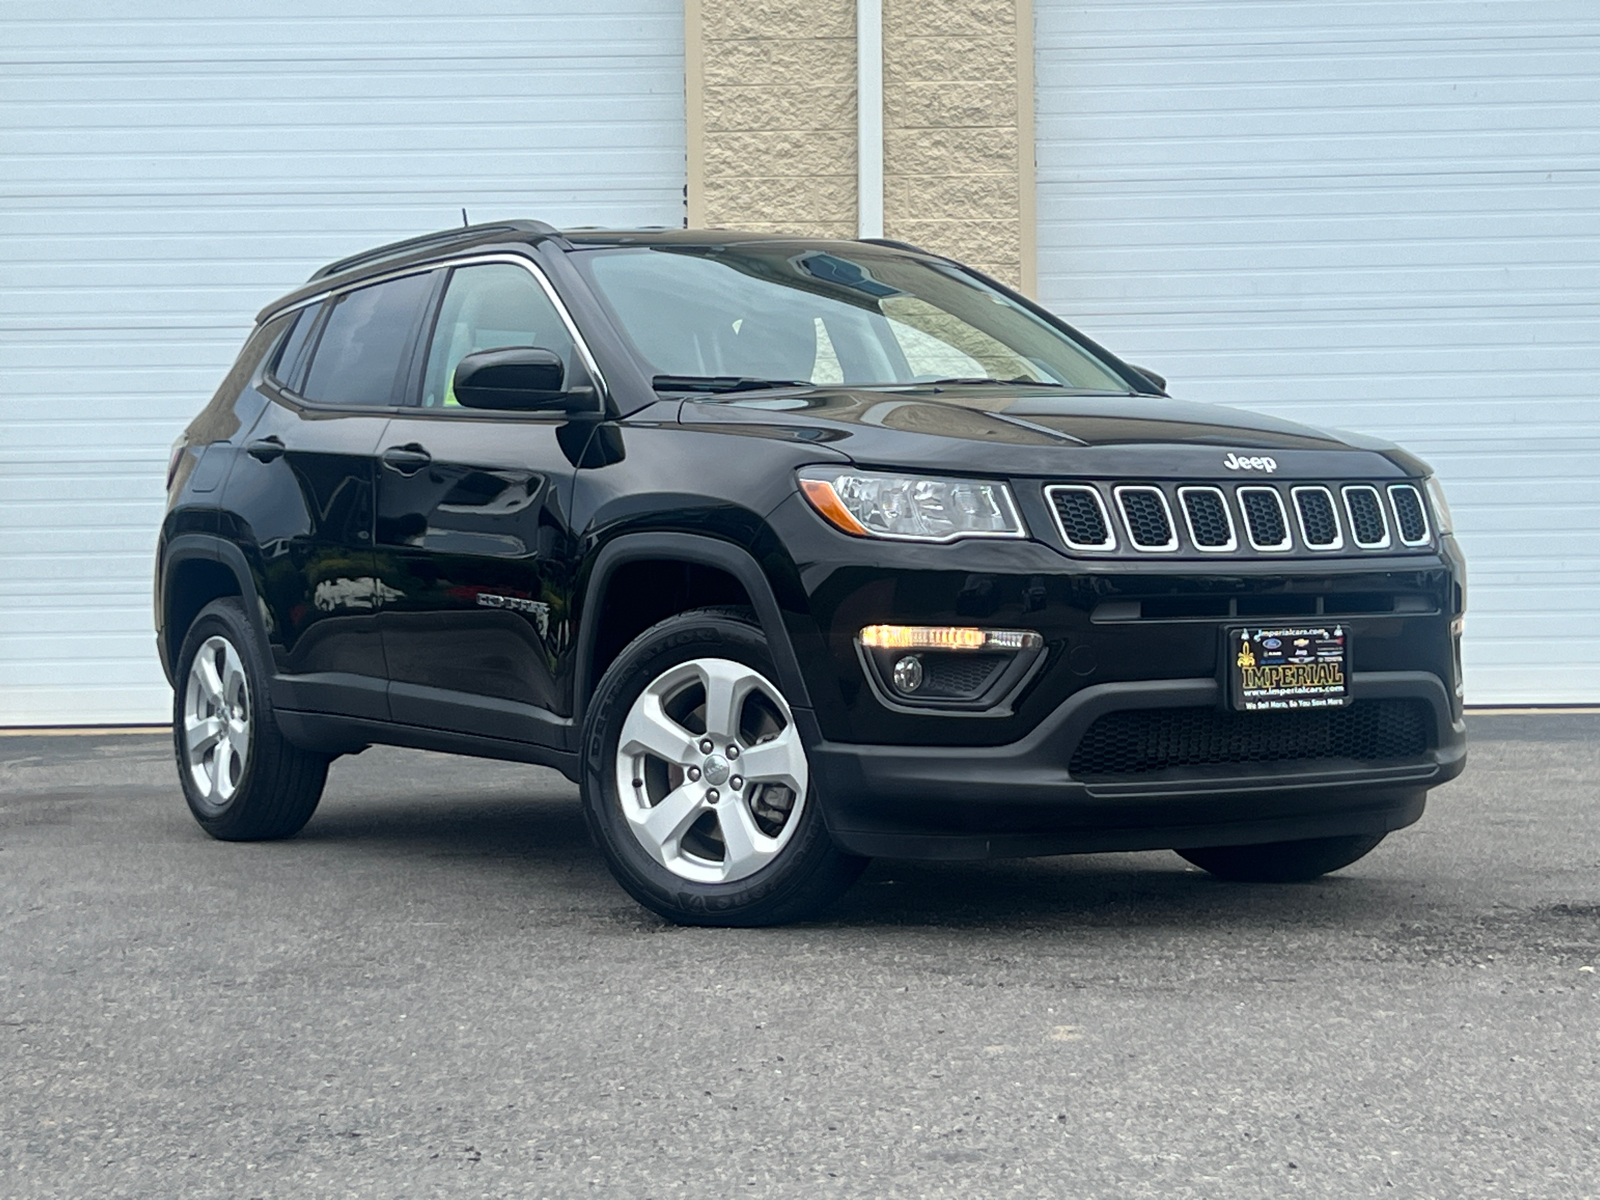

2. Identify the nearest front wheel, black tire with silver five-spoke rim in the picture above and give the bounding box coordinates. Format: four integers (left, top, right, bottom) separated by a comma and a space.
582, 608, 867, 926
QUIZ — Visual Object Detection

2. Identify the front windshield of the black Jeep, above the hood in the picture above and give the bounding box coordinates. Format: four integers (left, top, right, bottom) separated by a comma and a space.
574, 242, 1130, 395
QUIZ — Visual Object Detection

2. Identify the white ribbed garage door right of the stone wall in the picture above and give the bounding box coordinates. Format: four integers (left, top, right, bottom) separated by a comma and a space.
1035, 0, 1600, 704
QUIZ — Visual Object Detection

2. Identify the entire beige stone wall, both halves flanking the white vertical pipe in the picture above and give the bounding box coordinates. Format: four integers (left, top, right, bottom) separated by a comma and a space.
685, 0, 1034, 291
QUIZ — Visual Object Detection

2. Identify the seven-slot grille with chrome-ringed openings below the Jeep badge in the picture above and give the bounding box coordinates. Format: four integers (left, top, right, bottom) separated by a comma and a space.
1045, 482, 1434, 555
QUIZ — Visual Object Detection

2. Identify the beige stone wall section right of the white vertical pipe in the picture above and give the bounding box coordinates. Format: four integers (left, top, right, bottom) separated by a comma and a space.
883, 0, 1034, 286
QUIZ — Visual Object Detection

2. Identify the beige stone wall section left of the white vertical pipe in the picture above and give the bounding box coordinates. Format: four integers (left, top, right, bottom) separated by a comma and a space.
686, 0, 856, 237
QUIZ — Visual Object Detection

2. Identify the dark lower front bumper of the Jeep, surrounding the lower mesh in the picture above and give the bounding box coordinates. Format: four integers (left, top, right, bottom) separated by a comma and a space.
797, 670, 1466, 859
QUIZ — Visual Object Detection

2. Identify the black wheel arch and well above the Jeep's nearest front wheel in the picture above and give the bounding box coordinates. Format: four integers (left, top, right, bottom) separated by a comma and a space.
573, 533, 811, 722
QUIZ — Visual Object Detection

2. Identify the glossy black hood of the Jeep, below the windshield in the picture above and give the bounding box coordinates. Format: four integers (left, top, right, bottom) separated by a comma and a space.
680, 386, 1426, 478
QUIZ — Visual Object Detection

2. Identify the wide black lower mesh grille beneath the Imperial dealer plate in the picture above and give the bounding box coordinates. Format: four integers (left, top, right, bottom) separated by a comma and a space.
1067, 699, 1430, 779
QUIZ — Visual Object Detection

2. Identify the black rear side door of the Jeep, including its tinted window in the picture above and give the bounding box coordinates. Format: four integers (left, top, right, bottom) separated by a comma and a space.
224, 274, 437, 720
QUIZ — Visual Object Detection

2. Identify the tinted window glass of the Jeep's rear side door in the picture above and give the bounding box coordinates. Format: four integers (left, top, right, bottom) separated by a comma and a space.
301, 274, 434, 406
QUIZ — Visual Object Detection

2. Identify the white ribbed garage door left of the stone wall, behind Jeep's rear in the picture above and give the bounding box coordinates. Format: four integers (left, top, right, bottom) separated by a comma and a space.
0, 0, 685, 725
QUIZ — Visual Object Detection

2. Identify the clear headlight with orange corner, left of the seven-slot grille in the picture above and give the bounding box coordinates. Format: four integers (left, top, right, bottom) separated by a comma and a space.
800, 469, 1027, 542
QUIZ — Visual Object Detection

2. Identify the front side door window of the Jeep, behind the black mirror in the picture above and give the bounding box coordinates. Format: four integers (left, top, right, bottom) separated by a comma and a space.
422, 262, 574, 408
